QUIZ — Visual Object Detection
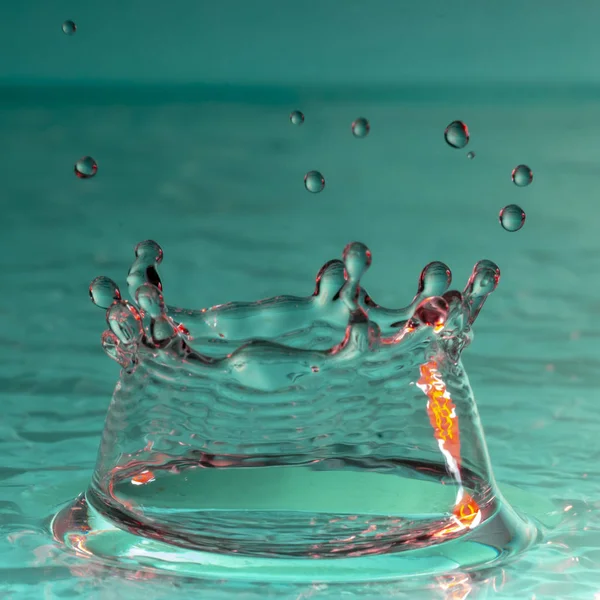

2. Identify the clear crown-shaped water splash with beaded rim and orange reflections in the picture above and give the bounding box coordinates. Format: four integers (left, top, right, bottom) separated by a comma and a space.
53, 241, 538, 581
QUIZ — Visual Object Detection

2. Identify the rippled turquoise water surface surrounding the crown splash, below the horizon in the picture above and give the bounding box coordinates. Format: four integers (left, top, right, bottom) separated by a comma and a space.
0, 86, 600, 600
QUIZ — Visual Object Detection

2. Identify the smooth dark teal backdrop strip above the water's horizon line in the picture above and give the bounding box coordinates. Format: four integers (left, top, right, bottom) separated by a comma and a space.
0, 0, 600, 84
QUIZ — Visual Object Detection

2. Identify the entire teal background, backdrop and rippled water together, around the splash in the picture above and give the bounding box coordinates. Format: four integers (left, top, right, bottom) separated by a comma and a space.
0, 0, 600, 600
